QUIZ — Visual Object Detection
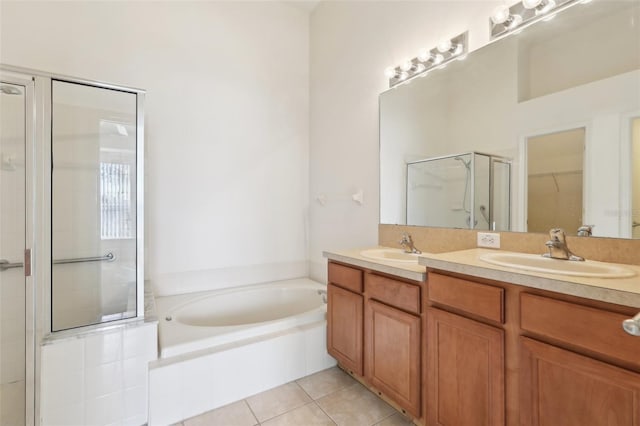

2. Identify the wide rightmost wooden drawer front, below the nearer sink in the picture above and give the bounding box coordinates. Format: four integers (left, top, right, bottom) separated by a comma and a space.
520, 293, 640, 365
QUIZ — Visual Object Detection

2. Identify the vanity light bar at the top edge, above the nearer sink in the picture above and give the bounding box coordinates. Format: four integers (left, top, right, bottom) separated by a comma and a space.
489, 0, 586, 39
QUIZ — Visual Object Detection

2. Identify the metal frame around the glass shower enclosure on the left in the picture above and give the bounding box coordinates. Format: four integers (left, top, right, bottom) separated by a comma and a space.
0, 63, 146, 426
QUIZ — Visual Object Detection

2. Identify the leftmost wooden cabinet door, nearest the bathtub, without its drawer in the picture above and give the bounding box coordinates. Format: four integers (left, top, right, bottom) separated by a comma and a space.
327, 284, 363, 376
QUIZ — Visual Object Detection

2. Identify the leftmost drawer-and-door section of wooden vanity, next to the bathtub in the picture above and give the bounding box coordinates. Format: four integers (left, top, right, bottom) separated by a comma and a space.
327, 263, 364, 376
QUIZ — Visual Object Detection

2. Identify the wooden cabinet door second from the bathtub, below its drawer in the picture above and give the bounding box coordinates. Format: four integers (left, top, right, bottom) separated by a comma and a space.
365, 300, 421, 417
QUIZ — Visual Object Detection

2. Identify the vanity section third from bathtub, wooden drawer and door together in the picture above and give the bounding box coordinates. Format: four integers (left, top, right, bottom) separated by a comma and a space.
426, 273, 505, 426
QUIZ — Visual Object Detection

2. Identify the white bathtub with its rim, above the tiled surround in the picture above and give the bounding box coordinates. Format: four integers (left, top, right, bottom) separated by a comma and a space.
156, 278, 326, 358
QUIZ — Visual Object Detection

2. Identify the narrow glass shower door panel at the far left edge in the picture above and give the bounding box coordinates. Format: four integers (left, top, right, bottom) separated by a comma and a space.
0, 81, 27, 425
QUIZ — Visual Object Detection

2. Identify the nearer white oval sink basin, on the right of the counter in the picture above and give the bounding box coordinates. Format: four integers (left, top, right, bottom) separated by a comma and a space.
480, 252, 636, 278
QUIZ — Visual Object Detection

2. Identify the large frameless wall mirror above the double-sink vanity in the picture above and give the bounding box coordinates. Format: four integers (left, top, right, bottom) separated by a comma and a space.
380, 0, 640, 238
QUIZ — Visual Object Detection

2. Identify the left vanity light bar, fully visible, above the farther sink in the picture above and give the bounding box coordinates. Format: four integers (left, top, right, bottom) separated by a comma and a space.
384, 32, 468, 87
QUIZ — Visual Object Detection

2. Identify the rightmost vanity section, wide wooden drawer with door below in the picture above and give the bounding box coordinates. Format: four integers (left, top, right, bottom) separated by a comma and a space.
519, 292, 640, 426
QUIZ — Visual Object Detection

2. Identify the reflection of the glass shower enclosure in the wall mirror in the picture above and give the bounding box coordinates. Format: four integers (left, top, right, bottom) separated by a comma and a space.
407, 152, 511, 231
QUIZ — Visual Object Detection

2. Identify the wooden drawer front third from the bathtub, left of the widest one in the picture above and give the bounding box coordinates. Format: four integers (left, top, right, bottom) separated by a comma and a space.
427, 272, 504, 323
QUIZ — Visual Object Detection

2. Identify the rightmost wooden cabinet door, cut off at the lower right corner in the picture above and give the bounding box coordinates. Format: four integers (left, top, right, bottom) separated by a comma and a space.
520, 337, 640, 426
